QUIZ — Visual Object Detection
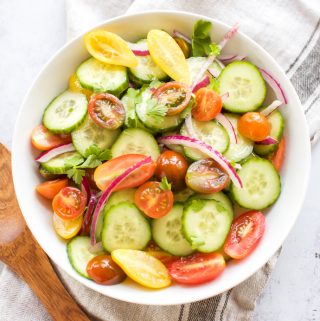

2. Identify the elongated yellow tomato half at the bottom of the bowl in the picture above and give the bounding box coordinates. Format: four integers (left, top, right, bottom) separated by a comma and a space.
111, 249, 171, 289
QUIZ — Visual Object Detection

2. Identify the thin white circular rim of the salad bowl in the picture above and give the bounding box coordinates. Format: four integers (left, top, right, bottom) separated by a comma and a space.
11, 10, 311, 306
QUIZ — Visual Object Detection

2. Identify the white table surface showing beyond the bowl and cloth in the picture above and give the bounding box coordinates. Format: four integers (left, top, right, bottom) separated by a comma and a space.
0, 0, 320, 321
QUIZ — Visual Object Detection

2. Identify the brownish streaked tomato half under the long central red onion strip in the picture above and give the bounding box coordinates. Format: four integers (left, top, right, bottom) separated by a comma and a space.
186, 158, 230, 194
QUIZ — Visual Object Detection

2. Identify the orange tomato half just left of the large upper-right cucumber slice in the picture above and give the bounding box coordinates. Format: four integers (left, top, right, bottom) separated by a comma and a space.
192, 87, 222, 121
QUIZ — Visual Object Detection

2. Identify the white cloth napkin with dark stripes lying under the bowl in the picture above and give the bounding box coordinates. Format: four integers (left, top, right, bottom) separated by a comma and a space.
0, 0, 320, 321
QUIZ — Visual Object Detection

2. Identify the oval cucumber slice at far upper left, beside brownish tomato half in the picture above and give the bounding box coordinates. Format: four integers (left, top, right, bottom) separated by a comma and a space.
42, 90, 88, 134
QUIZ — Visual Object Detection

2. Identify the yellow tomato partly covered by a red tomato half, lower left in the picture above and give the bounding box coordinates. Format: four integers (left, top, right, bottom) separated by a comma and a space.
52, 213, 83, 240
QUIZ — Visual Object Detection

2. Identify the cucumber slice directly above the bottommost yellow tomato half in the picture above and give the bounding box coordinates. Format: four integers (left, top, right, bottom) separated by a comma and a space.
101, 202, 151, 253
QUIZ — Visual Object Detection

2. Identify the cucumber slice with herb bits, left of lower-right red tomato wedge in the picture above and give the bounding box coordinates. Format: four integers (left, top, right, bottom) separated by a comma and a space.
182, 200, 233, 253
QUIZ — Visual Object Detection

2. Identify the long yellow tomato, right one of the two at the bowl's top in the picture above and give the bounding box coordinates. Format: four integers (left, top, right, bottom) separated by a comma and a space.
147, 29, 190, 85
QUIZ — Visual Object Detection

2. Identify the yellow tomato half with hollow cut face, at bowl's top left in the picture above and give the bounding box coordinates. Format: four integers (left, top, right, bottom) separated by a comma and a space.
84, 30, 138, 68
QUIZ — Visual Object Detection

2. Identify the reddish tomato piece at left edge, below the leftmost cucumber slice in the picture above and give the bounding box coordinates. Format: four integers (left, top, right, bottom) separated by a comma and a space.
31, 125, 71, 150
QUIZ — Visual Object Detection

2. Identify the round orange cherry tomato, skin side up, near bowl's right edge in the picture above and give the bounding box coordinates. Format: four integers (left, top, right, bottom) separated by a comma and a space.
238, 112, 271, 142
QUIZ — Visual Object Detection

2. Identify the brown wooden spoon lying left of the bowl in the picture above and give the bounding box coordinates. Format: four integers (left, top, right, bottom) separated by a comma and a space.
0, 144, 90, 321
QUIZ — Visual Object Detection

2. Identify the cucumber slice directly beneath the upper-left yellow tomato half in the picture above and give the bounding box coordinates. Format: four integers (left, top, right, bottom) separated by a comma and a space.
76, 57, 129, 96
